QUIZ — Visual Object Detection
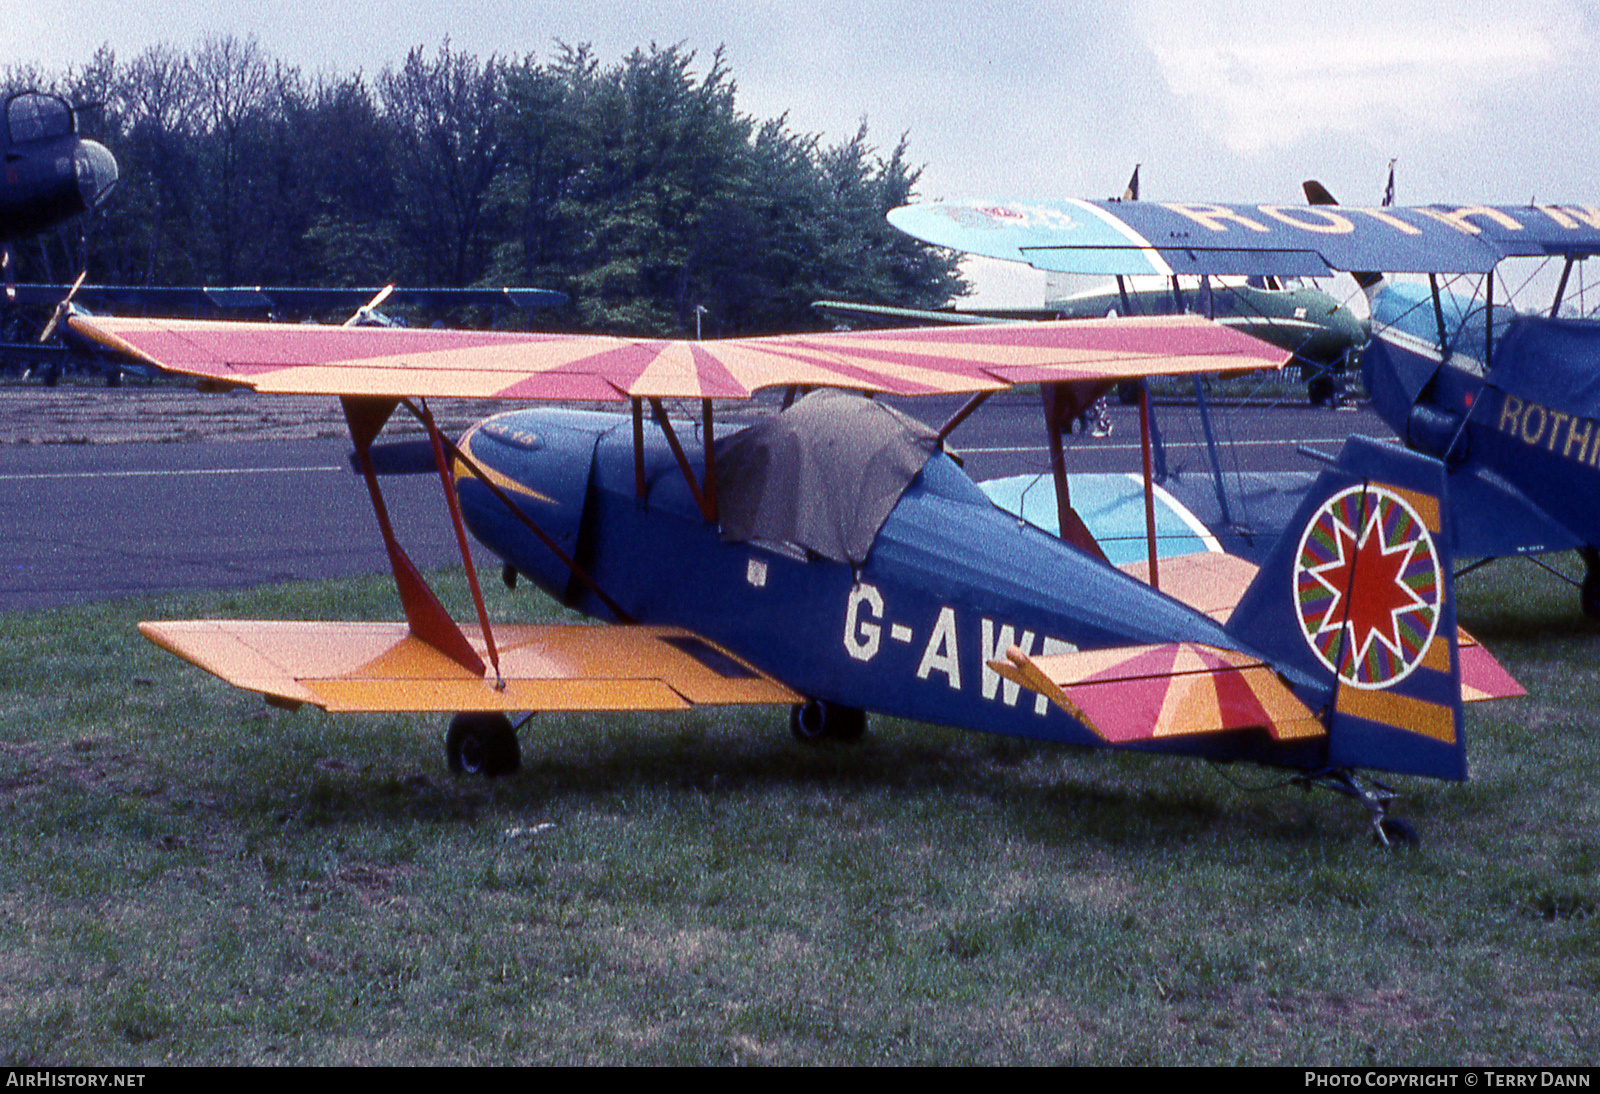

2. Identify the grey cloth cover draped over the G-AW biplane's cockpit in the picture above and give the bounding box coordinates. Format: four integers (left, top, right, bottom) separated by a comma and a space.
717, 389, 939, 566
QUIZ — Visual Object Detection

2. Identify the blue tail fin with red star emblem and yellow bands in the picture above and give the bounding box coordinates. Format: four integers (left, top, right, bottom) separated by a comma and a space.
1229, 437, 1467, 779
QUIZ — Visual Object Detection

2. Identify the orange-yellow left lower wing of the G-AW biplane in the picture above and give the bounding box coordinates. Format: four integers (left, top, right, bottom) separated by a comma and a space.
139, 619, 802, 712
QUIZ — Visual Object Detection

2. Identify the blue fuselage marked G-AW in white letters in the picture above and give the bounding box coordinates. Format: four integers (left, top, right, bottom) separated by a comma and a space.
458, 409, 1238, 750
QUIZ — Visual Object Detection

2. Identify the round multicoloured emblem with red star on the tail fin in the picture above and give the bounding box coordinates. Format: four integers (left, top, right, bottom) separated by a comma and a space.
1294, 485, 1443, 688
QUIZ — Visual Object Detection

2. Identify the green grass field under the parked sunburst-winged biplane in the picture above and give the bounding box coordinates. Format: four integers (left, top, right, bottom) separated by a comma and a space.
0, 550, 1600, 1065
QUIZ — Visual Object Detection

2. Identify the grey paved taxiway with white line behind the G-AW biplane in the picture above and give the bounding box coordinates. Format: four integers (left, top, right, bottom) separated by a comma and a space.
0, 392, 1389, 611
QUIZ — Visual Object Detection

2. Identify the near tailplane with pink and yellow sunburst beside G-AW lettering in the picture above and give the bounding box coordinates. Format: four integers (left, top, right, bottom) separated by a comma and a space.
989, 643, 1325, 744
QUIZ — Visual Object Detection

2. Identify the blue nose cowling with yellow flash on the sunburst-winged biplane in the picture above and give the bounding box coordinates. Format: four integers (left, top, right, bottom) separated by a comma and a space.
454, 409, 619, 601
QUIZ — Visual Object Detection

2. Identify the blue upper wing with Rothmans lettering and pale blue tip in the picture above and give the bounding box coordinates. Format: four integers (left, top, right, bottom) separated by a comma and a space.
890, 200, 1600, 277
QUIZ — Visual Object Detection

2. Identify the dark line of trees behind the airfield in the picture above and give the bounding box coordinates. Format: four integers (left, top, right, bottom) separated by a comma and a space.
0, 37, 965, 336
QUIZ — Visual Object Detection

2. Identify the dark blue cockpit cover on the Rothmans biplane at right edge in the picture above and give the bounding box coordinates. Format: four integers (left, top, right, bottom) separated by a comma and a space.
1490, 315, 1600, 417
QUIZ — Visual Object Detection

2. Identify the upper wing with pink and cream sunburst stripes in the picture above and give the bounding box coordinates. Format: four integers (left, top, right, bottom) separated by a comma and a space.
69, 315, 1286, 401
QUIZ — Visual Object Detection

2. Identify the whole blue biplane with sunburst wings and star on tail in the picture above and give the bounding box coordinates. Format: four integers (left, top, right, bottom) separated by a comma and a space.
67, 307, 1520, 843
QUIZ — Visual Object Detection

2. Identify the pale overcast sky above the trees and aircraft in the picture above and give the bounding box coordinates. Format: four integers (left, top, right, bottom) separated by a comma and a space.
0, 0, 1600, 300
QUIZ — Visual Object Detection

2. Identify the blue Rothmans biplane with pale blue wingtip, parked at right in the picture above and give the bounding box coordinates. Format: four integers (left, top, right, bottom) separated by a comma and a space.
890, 191, 1600, 616
